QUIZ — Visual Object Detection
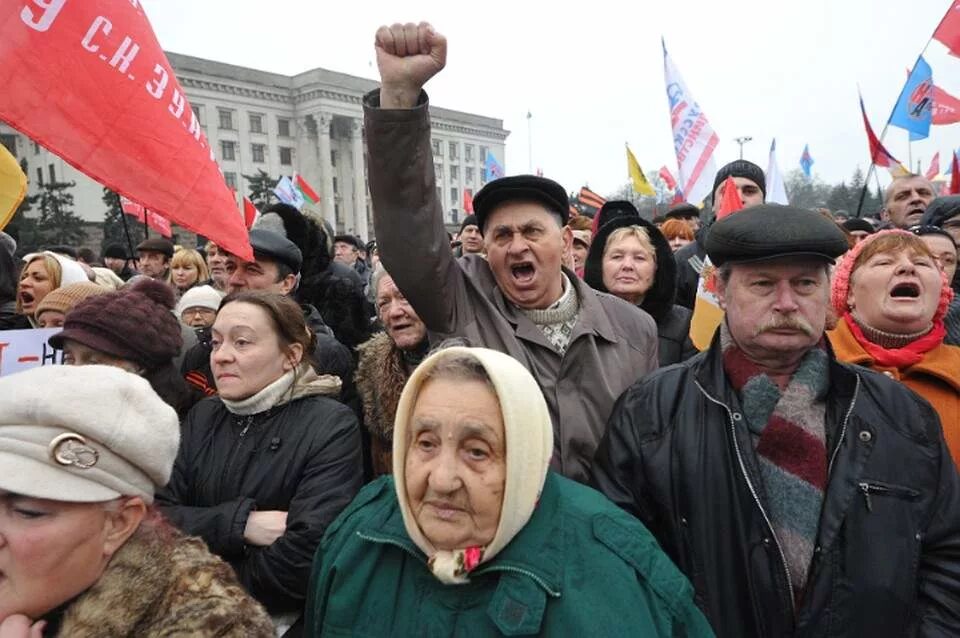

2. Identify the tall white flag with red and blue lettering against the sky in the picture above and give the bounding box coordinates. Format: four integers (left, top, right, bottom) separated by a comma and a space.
663, 42, 720, 204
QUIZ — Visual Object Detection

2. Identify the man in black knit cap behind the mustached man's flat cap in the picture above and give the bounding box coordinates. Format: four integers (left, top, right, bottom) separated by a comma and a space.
674, 160, 767, 310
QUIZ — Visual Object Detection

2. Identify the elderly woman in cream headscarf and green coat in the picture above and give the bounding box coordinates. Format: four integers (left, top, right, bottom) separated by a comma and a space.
306, 347, 713, 636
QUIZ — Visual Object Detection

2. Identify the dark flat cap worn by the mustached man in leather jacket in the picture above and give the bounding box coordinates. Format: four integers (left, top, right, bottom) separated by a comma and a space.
706, 204, 847, 266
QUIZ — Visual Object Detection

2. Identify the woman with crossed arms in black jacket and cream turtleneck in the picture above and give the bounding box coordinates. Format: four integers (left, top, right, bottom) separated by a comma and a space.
158, 292, 363, 631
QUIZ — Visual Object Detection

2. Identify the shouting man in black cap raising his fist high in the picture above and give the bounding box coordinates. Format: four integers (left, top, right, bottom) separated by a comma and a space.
364, 23, 657, 480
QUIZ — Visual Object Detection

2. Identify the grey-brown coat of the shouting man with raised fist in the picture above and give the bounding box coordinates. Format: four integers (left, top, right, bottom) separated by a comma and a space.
364, 92, 657, 481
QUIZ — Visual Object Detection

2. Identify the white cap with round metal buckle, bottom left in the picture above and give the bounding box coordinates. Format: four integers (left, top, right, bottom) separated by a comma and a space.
0, 365, 180, 503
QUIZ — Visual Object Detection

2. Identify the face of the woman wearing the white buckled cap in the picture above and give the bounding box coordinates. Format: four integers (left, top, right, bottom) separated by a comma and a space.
0, 492, 118, 622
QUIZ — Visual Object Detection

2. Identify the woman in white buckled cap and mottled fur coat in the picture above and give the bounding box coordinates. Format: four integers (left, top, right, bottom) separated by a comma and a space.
0, 365, 273, 638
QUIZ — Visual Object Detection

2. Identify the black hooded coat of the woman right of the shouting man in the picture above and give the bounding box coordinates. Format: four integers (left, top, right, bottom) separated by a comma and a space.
583, 214, 697, 367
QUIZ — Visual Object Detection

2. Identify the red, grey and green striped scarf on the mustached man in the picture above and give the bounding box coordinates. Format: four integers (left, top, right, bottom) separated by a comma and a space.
720, 323, 829, 604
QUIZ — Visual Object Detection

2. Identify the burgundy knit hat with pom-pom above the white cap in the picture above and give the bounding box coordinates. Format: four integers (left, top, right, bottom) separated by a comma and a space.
50, 279, 183, 369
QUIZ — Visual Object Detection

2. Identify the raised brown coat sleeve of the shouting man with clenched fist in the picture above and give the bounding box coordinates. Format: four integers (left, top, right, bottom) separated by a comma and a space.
363, 91, 466, 333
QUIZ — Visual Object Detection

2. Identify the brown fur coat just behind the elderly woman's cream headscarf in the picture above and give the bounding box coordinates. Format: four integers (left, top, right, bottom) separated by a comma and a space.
356, 332, 410, 477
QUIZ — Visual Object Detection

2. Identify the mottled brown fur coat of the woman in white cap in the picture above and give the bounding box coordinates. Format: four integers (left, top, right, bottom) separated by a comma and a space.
57, 521, 274, 638
